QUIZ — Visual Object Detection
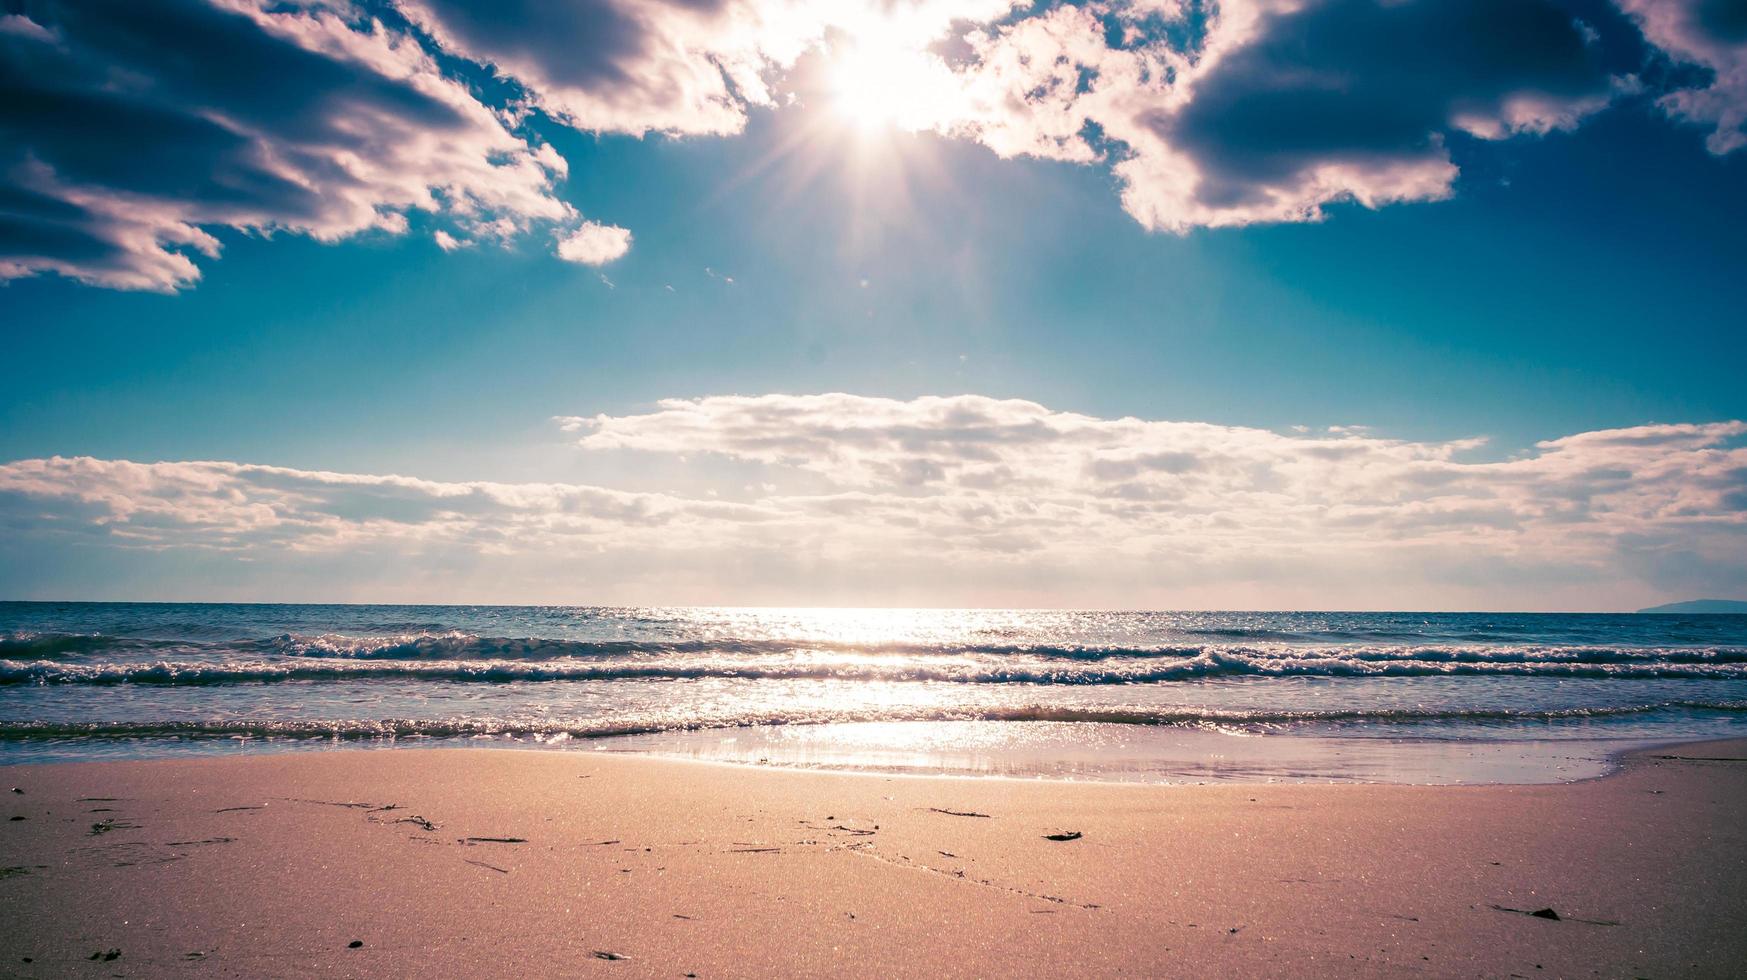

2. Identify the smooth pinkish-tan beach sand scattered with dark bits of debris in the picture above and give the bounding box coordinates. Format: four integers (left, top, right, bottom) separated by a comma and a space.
0, 742, 1747, 978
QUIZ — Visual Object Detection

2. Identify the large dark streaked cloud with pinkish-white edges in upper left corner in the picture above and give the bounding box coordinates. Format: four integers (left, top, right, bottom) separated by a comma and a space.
0, 0, 571, 292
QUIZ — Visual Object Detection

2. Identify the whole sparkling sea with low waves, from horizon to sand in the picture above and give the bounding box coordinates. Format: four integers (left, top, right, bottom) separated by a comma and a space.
0, 603, 1747, 783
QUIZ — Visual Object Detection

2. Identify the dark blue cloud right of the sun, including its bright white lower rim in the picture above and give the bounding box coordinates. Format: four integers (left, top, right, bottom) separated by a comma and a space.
1118, 0, 1611, 229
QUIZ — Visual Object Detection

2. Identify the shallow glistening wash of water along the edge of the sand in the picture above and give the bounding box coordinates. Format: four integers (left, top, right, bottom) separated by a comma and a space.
0, 721, 1733, 786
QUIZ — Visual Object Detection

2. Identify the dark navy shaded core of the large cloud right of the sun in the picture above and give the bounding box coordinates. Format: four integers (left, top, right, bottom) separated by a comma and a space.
1153, 0, 1609, 208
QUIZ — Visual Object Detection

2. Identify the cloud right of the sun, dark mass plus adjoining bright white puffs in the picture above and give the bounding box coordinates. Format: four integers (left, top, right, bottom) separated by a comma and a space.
950, 0, 1619, 232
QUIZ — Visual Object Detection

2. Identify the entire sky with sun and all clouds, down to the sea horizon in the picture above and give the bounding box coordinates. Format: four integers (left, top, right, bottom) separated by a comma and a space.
0, 0, 1747, 610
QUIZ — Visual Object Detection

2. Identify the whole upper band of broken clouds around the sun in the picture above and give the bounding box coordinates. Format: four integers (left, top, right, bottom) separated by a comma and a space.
0, 0, 1747, 292
